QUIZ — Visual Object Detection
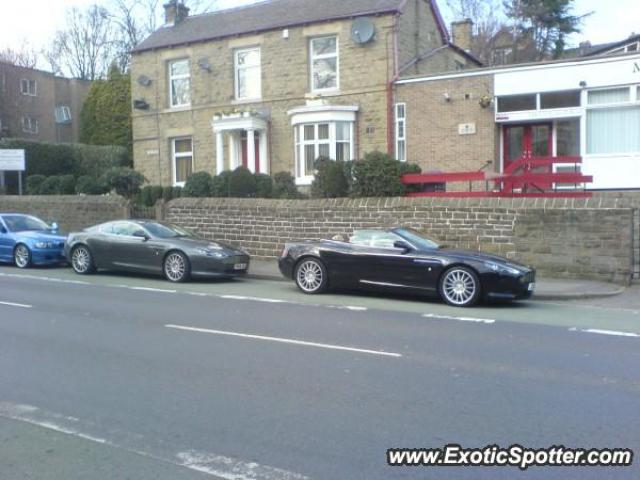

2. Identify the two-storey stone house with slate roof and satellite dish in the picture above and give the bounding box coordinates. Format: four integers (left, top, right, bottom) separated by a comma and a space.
131, 0, 478, 186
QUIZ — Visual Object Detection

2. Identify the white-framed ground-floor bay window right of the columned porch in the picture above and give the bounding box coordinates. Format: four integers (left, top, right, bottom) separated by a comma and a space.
294, 121, 355, 185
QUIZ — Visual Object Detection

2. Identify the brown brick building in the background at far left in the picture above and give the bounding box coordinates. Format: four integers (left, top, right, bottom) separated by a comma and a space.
0, 62, 91, 143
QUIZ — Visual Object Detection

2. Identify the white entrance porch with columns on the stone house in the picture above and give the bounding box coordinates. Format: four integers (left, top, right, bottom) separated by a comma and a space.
212, 112, 269, 175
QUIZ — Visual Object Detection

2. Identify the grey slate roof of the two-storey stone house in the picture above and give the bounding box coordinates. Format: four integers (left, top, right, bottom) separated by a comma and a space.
133, 0, 408, 53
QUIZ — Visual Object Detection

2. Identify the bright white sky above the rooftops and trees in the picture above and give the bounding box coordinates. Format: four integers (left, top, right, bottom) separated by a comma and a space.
0, 0, 640, 61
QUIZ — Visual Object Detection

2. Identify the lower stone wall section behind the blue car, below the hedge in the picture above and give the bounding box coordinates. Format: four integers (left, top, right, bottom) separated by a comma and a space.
0, 195, 129, 232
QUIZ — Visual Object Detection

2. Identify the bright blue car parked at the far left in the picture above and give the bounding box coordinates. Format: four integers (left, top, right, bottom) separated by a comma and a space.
0, 213, 66, 268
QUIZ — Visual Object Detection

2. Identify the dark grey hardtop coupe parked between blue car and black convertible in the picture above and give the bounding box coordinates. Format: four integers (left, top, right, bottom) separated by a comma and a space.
65, 220, 249, 282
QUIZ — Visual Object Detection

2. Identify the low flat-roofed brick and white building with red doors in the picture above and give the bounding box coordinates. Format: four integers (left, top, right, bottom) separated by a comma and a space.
395, 53, 640, 190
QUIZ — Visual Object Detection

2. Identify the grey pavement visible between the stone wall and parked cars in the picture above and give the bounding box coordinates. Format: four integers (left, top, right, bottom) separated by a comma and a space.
249, 259, 626, 300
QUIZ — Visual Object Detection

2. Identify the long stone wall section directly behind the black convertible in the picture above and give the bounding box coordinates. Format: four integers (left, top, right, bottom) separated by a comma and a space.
166, 197, 632, 283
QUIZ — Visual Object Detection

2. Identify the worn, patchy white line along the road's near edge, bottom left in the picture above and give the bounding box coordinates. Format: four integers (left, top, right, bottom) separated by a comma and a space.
0, 402, 308, 480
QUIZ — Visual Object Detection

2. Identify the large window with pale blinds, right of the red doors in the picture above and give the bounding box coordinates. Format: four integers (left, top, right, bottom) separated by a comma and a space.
587, 87, 640, 155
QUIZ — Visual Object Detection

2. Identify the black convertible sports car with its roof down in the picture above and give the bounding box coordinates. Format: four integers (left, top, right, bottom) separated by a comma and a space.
278, 228, 535, 307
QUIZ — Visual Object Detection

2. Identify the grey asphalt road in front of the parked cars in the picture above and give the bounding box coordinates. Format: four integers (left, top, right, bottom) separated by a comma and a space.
0, 267, 640, 480
